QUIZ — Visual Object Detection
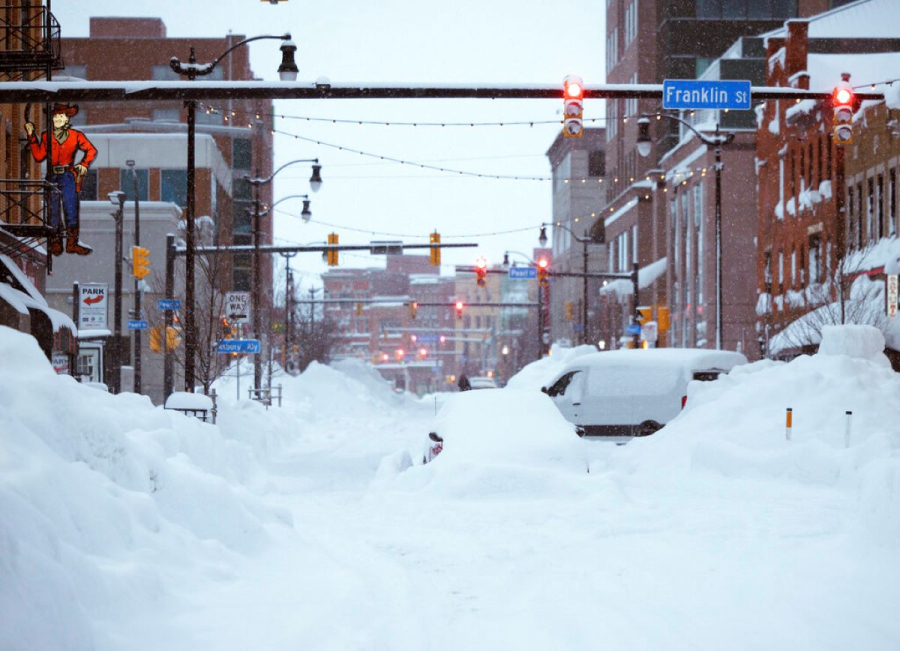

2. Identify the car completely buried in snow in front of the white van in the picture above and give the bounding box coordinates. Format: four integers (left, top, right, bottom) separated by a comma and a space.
423, 389, 587, 472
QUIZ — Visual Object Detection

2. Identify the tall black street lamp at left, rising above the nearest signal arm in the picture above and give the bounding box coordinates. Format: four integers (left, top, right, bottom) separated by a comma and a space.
169, 34, 298, 392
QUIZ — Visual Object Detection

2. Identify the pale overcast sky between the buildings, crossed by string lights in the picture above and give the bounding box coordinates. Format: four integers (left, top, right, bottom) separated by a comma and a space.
52, 0, 605, 290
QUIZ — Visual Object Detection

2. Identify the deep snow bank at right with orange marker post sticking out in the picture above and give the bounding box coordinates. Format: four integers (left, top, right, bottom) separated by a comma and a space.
604, 326, 900, 543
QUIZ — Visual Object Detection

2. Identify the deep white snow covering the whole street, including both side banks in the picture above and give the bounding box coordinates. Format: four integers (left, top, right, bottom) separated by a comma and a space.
0, 329, 900, 650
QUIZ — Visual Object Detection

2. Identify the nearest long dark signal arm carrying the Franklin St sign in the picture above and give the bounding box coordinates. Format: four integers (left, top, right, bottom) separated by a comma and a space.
0, 81, 884, 104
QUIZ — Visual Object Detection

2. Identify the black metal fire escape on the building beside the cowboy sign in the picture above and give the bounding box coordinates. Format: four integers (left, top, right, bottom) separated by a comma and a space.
0, 0, 63, 270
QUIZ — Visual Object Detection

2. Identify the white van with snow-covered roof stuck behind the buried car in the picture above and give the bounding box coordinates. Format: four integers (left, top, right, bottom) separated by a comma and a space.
541, 348, 747, 436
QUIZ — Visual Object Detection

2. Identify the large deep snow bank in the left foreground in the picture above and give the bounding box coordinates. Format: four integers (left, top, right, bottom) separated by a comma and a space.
0, 327, 289, 649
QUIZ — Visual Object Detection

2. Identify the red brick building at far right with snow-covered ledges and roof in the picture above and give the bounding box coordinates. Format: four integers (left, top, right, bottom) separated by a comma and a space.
756, 0, 900, 355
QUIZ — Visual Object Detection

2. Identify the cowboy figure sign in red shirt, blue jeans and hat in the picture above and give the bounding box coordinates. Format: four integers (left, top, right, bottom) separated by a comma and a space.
25, 104, 97, 255
